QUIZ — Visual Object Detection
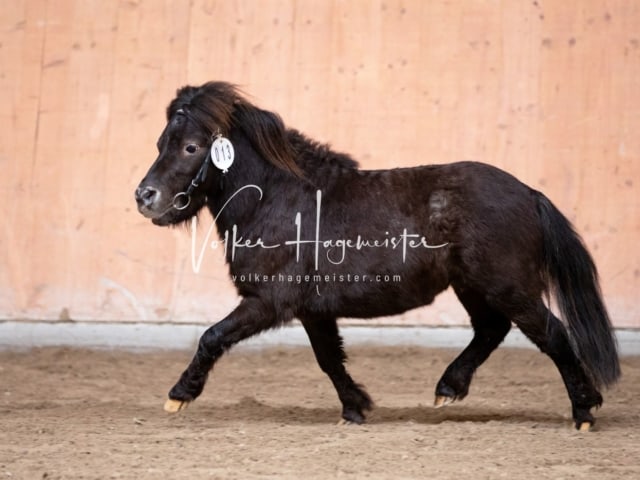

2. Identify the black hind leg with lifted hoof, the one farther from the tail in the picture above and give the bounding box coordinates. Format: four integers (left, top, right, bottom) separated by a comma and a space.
435, 288, 511, 407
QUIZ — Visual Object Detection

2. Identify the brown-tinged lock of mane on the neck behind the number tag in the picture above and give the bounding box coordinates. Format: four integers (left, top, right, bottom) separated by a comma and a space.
232, 100, 304, 178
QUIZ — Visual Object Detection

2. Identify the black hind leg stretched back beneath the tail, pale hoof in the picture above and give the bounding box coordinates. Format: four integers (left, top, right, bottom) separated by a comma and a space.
512, 300, 602, 430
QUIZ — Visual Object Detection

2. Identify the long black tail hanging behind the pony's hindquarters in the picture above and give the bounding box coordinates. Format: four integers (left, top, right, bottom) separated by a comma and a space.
538, 194, 620, 387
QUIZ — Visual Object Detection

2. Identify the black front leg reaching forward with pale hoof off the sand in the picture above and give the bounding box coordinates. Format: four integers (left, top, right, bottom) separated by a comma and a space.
164, 298, 277, 413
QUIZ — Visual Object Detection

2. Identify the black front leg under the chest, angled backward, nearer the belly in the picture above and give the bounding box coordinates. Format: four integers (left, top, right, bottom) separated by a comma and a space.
301, 316, 373, 424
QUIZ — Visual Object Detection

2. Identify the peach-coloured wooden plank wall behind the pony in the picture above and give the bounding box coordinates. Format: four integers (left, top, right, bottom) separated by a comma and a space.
0, 0, 640, 327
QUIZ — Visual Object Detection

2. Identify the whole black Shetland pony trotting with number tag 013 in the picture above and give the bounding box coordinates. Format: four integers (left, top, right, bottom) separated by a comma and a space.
135, 82, 620, 429
